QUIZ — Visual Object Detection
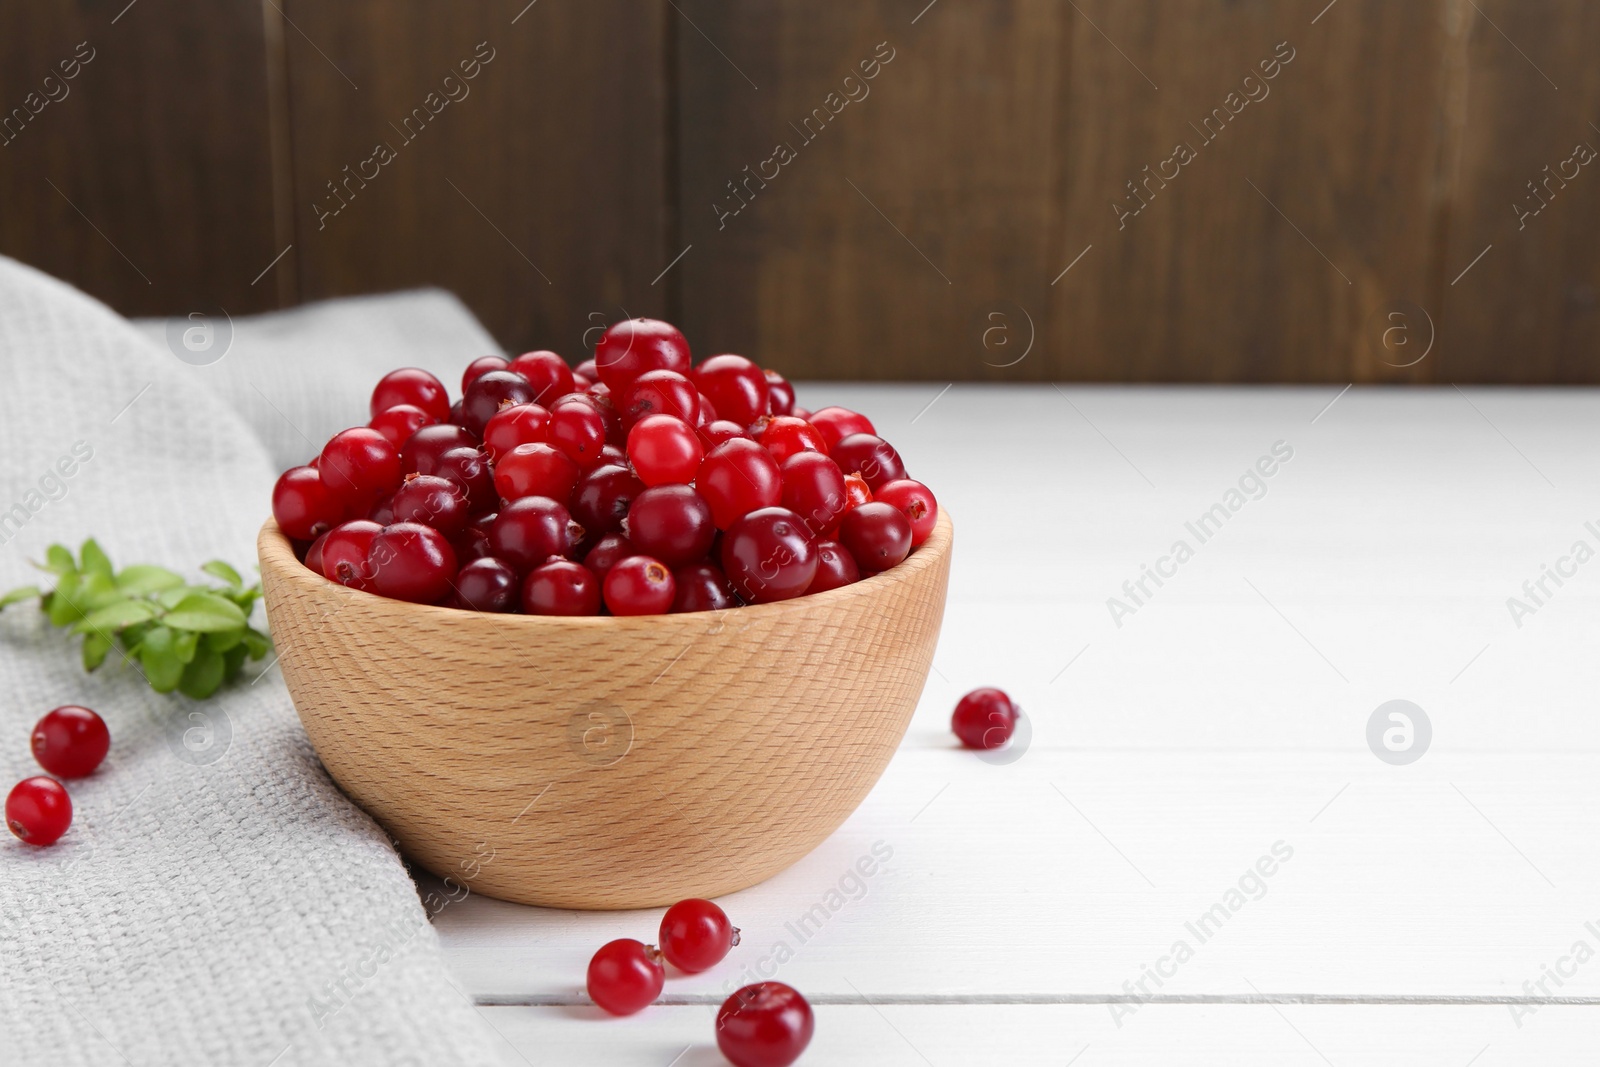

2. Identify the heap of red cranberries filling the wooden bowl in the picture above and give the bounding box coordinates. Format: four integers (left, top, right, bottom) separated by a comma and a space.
272, 318, 939, 616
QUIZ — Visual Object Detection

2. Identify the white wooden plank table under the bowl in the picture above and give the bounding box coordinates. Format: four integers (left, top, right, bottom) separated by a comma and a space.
422, 384, 1600, 1067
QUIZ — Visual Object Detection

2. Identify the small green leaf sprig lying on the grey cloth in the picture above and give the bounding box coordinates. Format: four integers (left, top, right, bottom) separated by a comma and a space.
0, 537, 272, 701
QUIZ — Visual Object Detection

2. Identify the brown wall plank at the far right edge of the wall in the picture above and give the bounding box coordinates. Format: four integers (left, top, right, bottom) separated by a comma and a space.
1443, 0, 1600, 384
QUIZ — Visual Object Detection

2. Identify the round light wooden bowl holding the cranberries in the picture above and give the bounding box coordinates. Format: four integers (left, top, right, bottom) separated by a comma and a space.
258, 512, 952, 909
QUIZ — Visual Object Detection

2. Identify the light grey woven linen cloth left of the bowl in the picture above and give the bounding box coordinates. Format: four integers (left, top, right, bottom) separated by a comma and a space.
0, 258, 506, 1067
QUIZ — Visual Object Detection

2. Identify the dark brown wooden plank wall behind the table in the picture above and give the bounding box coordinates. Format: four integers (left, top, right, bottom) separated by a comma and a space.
0, 0, 1600, 382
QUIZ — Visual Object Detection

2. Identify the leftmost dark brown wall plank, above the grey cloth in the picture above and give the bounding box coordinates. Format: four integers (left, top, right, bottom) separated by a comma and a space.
0, 0, 278, 315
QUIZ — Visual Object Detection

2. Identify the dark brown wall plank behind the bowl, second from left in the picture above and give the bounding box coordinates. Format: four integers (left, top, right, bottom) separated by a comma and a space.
285, 0, 670, 360
